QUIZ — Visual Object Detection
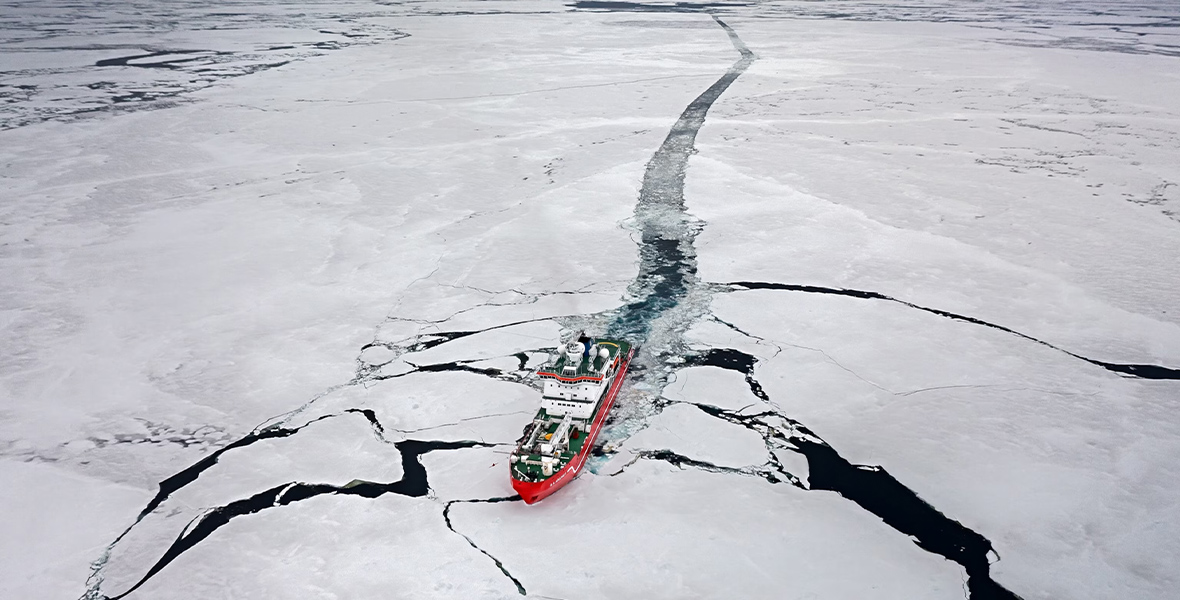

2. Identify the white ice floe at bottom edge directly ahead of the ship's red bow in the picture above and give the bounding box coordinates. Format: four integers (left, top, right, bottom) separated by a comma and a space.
451, 461, 962, 599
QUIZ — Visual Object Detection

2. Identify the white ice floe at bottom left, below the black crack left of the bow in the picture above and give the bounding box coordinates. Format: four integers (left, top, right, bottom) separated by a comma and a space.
118, 495, 516, 600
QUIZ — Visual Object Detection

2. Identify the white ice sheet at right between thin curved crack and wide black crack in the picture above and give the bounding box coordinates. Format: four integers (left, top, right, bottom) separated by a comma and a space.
698, 292, 1180, 598
